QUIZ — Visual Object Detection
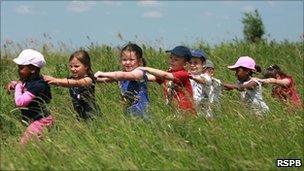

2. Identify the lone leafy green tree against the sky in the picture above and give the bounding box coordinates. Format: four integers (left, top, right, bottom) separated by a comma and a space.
242, 9, 265, 43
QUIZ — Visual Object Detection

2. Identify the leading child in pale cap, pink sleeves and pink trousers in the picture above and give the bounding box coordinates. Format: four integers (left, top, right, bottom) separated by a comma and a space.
7, 49, 54, 144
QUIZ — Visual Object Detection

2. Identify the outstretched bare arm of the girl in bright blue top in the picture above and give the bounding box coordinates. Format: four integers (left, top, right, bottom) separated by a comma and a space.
94, 69, 144, 81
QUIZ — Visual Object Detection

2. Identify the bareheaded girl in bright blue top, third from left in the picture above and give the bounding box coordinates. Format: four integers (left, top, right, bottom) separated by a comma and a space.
94, 43, 149, 117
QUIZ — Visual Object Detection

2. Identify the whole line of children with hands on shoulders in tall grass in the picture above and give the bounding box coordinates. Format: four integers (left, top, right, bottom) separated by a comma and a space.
7, 43, 302, 144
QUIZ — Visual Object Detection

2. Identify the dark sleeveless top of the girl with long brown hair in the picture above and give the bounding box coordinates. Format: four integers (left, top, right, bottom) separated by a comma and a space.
69, 74, 99, 119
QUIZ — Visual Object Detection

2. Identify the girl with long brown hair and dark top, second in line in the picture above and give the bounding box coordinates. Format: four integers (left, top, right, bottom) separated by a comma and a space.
44, 50, 99, 120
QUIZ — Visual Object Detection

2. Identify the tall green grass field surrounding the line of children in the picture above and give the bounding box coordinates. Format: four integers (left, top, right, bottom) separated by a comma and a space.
0, 41, 304, 170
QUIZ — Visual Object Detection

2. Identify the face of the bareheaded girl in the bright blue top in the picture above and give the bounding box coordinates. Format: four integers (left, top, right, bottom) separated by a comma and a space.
121, 51, 141, 72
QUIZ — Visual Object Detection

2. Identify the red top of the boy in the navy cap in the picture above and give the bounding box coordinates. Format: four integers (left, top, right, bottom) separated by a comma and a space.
156, 69, 195, 114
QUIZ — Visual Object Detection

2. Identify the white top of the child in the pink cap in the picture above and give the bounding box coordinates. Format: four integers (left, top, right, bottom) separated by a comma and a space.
239, 79, 269, 115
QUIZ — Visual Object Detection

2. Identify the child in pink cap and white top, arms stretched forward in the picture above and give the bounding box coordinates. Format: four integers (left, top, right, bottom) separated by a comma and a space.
223, 56, 269, 116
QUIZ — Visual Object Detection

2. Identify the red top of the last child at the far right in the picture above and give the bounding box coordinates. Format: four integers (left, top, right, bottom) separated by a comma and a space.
272, 76, 302, 106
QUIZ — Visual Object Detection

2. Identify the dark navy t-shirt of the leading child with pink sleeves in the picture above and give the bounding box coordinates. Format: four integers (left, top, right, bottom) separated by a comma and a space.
21, 76, 52, 122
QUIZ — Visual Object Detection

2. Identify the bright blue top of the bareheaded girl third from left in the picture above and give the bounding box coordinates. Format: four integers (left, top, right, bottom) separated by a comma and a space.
120, 71, 149, 116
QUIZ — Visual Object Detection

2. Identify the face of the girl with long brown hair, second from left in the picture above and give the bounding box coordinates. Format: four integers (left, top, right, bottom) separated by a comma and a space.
70, 58, 88, 78
